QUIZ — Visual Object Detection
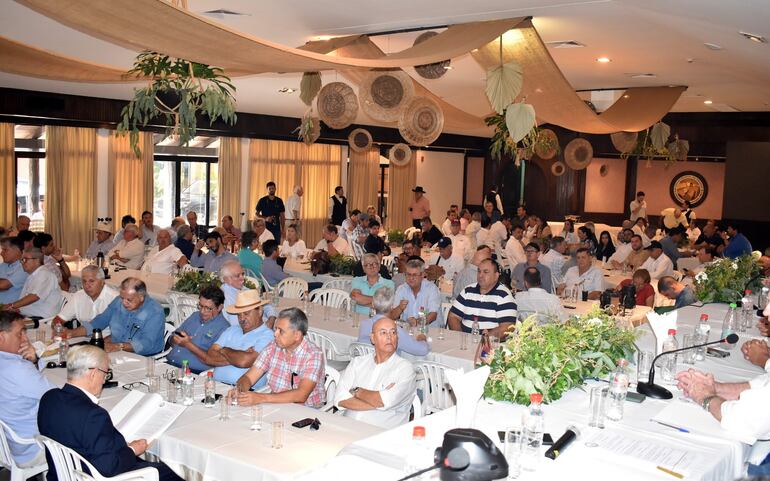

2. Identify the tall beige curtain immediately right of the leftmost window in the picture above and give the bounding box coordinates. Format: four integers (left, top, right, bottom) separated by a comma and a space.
45, 126, 96, 252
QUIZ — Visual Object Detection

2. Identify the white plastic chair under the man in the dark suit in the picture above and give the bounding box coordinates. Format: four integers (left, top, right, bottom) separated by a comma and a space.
35, 435, 158, 481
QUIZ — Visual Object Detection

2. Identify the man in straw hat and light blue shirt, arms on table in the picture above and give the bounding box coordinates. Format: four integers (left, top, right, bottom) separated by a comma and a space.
207, 289, 274, 389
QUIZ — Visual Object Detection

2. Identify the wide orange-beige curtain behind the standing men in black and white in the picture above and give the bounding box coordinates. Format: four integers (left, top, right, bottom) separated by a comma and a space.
249, 139, 342, 244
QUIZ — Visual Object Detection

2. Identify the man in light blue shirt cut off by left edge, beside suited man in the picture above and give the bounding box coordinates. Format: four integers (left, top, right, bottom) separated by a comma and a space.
0, 311, 56, 467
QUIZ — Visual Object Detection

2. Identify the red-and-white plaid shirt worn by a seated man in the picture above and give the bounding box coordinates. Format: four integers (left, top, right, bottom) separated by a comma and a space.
254, 337, 326, 408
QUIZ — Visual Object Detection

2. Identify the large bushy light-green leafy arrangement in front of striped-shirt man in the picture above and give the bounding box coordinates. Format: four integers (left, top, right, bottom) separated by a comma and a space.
484, 307, 636, 405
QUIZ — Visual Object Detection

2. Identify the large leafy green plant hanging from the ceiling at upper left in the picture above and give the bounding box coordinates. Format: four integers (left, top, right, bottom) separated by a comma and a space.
118, 51, 236, 156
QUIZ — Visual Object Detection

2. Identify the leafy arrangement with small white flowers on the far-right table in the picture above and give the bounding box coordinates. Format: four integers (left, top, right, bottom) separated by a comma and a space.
695, 252, 762, 303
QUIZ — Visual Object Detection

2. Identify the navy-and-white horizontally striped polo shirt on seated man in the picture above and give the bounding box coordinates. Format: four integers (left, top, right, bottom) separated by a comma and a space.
449, 282, 516, 332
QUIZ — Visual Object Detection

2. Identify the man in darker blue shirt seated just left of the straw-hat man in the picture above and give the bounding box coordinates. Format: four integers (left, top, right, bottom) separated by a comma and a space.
166, 286, 230, 374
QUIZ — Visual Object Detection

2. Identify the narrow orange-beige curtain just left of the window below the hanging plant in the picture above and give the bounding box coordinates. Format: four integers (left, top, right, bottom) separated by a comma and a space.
107, 132, 155, 229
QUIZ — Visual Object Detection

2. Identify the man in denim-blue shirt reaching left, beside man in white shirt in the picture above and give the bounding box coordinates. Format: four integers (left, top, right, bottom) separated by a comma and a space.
78, 277, 165, 356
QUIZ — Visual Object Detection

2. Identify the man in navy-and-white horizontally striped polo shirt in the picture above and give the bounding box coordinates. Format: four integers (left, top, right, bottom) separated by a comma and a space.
448, 259, 516, 338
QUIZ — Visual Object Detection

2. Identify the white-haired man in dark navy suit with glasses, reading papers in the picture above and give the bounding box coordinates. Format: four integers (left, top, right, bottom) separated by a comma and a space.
37, 346, 182, 481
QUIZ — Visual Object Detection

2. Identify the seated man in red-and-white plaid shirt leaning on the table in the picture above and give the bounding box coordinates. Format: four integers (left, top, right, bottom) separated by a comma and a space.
228, 307, 326, 408
